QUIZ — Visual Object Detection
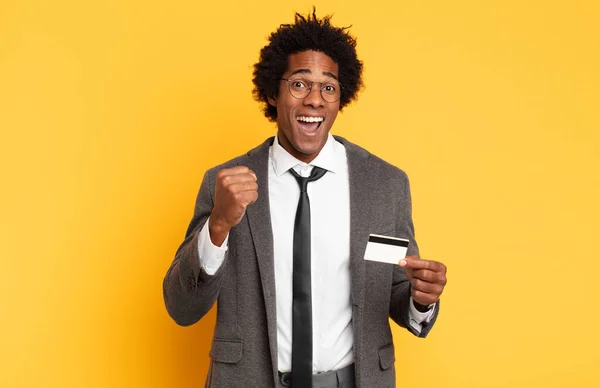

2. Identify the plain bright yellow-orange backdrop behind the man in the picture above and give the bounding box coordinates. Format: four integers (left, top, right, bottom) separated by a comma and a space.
0, 0, 600, 388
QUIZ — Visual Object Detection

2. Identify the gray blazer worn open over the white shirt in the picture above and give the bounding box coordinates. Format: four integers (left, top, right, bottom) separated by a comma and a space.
163, 136, 439, 388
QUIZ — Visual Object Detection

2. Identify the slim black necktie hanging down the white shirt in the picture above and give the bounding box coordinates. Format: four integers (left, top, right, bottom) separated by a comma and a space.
290, 167, 327, 388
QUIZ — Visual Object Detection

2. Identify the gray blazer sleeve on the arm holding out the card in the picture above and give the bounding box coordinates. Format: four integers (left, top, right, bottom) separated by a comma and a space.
390, 171, 440, 338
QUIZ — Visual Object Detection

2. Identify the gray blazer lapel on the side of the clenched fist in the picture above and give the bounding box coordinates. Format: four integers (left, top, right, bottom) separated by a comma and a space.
240, 137, 277, 384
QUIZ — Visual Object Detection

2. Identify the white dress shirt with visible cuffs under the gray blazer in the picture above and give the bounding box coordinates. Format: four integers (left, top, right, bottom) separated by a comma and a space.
198, 134, 433, 373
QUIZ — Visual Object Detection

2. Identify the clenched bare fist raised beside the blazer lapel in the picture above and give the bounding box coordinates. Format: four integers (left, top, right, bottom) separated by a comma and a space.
208, 166, 258, 246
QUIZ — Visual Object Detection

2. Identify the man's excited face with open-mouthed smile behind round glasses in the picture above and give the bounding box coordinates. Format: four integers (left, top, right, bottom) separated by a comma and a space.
269, 51, 340, 163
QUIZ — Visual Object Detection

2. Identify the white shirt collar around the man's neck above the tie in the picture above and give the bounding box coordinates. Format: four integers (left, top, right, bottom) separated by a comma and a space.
270, 133, 339, 176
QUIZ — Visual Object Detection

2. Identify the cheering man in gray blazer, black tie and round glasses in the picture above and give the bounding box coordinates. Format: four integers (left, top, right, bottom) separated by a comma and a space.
164, 11, 446, 388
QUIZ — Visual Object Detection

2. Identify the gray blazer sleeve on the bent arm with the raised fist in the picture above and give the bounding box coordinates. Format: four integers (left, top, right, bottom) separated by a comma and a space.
163, 169, 227, 326
